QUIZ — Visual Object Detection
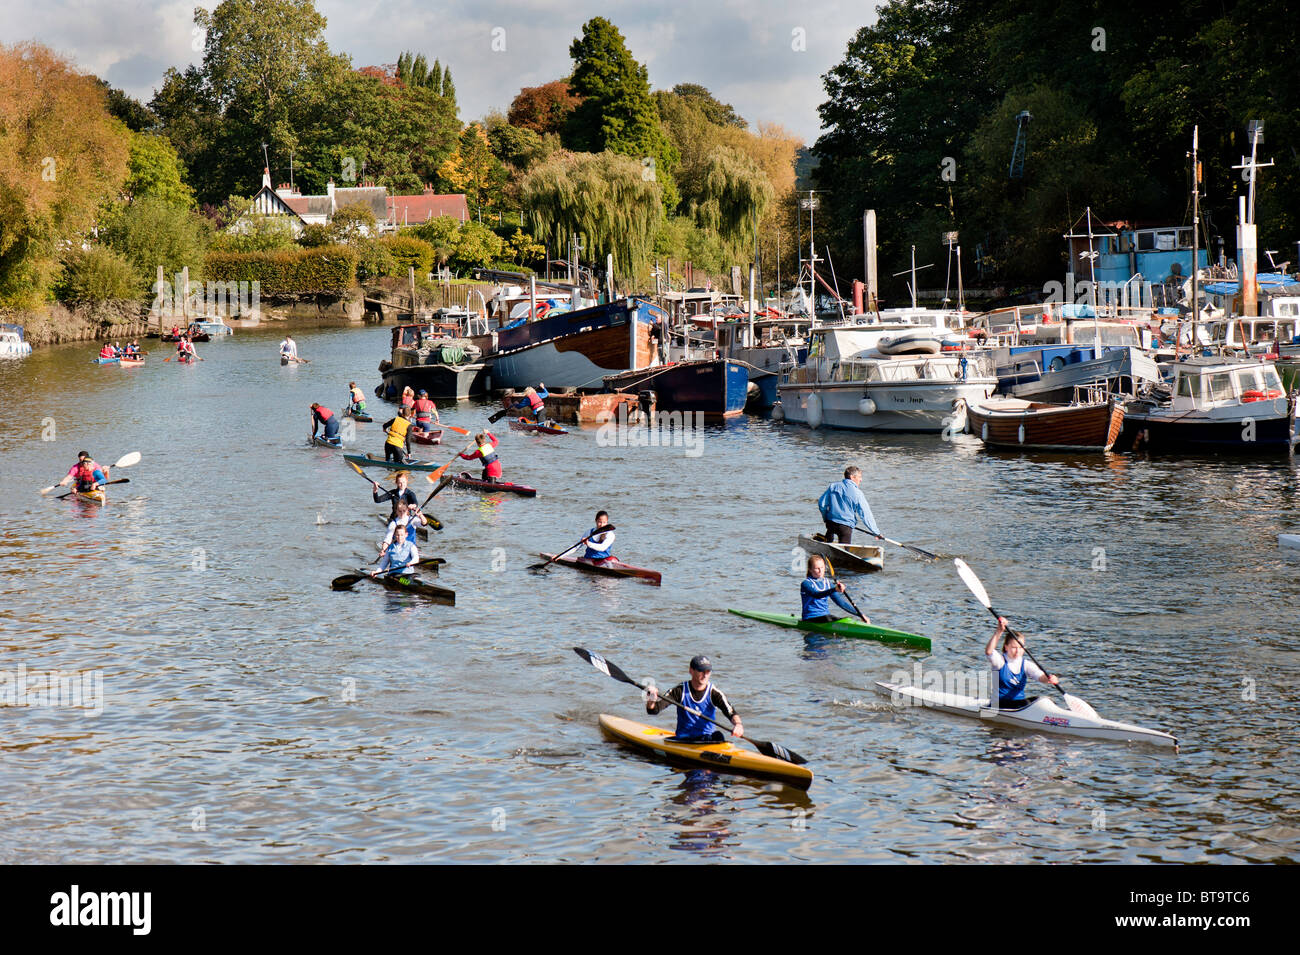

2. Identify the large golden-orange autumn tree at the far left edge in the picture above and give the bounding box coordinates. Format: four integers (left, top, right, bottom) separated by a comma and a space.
0, 43, 130, 307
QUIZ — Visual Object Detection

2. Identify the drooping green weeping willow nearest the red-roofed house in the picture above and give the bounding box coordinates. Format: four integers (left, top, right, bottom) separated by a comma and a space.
520, 152, 663, 275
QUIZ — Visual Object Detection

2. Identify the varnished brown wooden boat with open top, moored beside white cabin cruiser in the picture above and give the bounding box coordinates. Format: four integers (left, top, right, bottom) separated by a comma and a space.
966, 398, 1125, 451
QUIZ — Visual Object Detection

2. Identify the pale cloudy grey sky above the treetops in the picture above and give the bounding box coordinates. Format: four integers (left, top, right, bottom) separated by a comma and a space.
0, 0, 879, 144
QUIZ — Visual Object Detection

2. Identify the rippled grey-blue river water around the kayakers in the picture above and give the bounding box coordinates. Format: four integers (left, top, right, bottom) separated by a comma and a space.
0, 326, 1300, 863
